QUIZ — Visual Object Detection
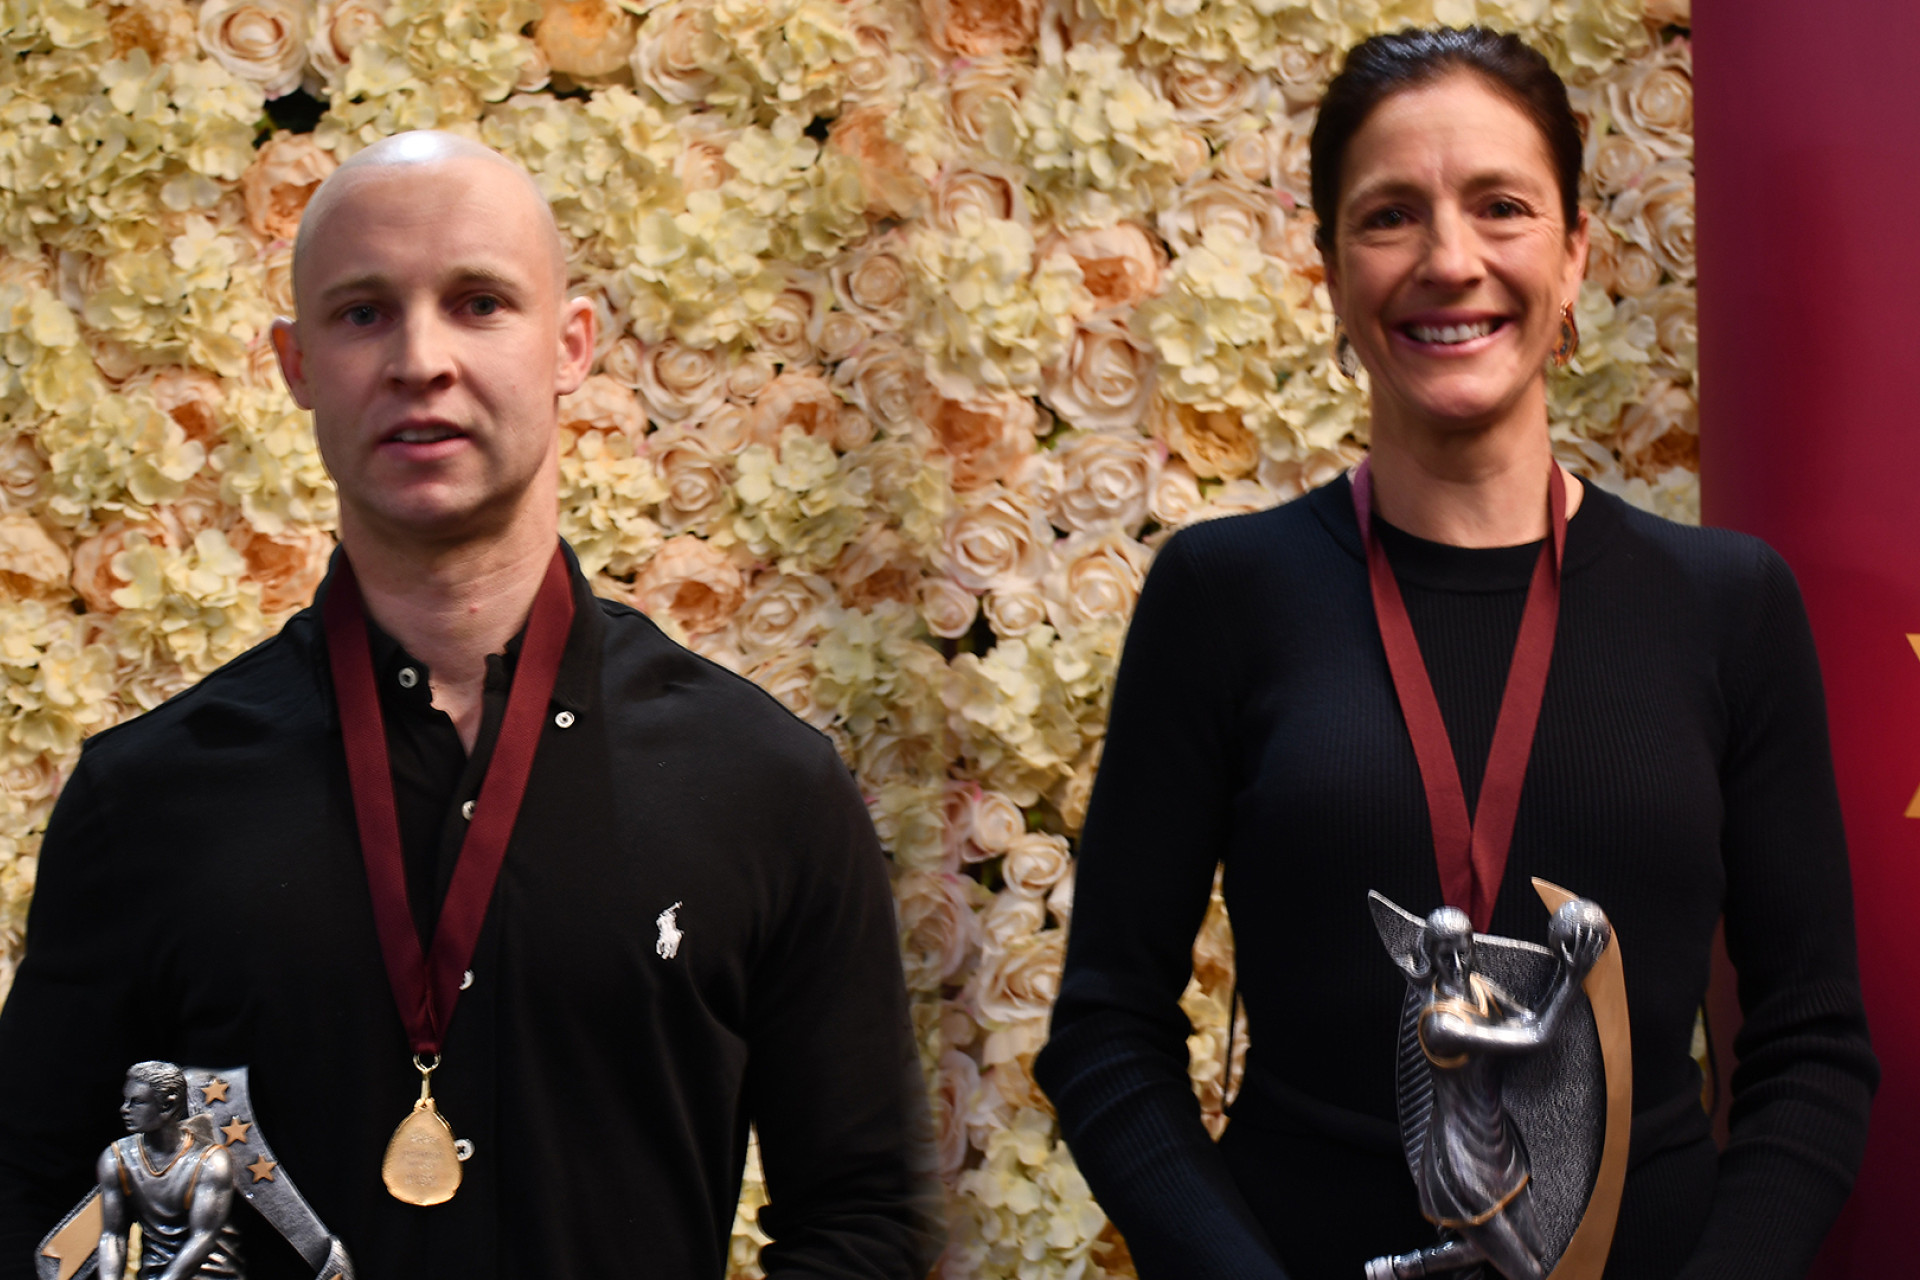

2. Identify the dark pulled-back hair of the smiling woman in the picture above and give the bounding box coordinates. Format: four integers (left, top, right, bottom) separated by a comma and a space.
1309, 27, 1584, 253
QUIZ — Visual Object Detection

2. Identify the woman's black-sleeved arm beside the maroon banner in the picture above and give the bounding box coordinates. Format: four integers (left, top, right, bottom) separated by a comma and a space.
1682, 549, 1878, 1280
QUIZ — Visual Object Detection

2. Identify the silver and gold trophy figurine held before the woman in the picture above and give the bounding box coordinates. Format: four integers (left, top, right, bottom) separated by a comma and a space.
1365, 881, 1632, 1280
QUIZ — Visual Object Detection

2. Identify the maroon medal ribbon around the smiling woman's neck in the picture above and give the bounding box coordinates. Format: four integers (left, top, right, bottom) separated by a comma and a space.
1354, 461, 1567, 933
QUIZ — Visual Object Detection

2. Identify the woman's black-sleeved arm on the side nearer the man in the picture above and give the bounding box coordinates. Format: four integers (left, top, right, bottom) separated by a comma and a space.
1035, 535, 1284, 1280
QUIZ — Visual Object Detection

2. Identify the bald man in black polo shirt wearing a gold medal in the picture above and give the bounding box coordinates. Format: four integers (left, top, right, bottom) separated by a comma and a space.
0, 132, 939, 1280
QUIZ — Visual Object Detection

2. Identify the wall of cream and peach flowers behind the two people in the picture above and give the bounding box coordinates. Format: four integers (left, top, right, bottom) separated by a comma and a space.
0, 0, 1697, 1278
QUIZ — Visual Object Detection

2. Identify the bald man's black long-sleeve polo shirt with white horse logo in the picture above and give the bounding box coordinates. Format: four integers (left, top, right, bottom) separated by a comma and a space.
0, 552, 937, 1280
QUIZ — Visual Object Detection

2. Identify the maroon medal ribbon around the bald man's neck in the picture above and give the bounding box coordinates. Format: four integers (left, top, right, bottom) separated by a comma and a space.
324, 547, 574, 1055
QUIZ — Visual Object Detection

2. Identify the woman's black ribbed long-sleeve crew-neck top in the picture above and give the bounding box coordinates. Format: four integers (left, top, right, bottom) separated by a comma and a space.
1037, 480, 1878, 1280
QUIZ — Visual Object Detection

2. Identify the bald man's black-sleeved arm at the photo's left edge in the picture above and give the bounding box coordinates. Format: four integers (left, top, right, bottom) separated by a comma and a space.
0, 758, 148, 1280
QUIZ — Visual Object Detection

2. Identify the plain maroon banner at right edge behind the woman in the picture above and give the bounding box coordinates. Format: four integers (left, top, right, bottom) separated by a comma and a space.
1693, 0, 1920, 1280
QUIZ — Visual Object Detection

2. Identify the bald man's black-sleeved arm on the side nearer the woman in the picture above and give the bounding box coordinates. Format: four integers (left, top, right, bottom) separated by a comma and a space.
747, 745, 943, 1280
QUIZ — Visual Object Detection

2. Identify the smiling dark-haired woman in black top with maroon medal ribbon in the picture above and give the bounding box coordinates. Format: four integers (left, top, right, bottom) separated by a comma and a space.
1035, 29, 1876, 1280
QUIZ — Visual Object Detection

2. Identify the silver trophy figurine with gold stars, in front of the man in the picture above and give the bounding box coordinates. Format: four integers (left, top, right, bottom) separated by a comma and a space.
33, 1061, 353, 1280
